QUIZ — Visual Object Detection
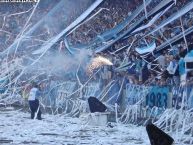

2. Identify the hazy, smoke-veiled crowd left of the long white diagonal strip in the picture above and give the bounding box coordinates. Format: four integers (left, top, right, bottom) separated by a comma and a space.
0, 0, 92, 98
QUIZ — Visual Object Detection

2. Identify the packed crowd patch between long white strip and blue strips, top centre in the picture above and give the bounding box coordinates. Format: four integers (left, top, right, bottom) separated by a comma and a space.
69, 0, 139, 45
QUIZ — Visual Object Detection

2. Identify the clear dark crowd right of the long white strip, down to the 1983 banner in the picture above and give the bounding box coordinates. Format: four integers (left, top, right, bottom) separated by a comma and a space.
65, 0, 193, 85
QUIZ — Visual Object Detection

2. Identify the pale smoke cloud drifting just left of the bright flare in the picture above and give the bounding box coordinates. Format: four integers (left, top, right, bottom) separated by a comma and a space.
25, 49, 92, 77
